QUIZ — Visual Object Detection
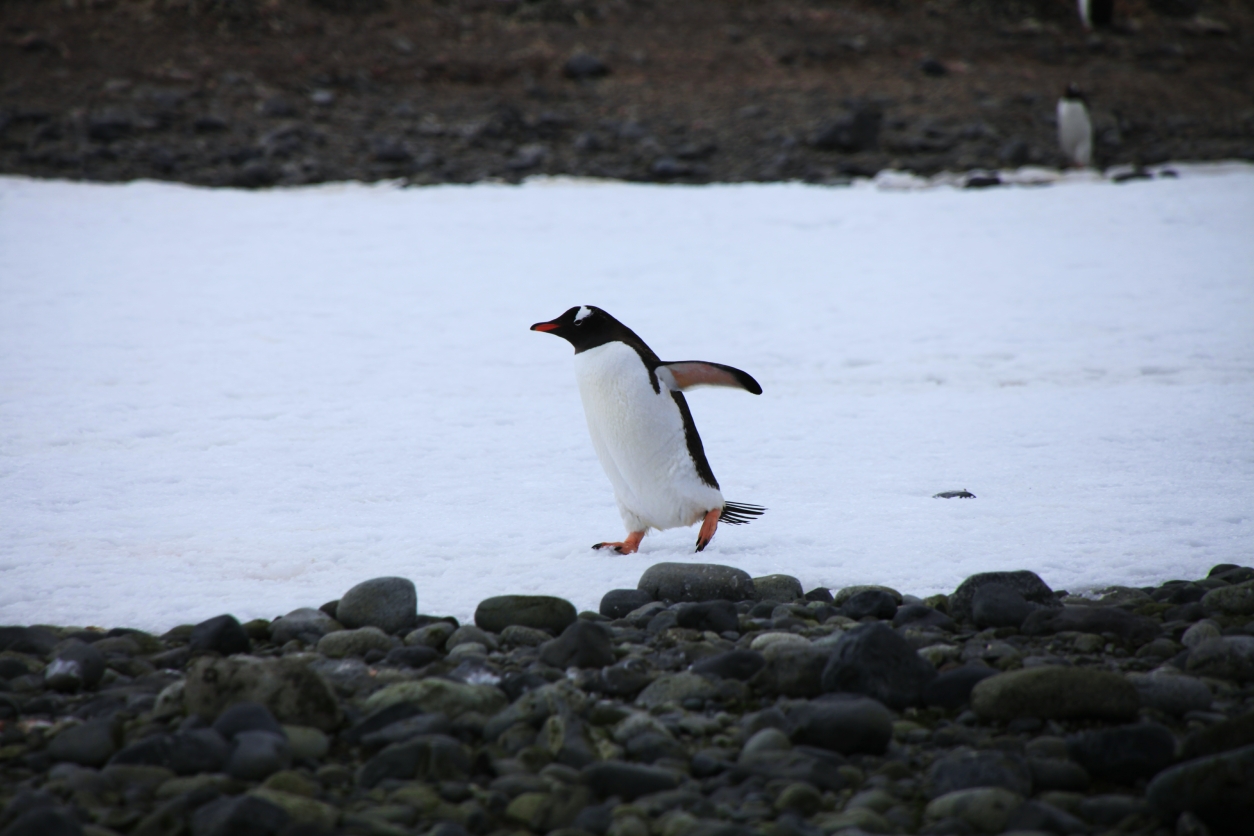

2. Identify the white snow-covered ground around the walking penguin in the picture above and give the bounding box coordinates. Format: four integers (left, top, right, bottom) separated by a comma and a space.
0, 167, 1254, 629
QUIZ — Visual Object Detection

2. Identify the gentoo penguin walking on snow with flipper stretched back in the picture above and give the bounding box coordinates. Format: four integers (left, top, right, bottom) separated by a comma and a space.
532, 305, 766, 554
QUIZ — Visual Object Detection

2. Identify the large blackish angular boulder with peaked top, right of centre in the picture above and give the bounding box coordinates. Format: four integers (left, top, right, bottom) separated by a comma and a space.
821, 624, 937, 709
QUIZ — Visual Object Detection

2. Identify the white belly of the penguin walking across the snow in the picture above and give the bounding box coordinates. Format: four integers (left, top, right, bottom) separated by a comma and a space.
574, 342, 722, 531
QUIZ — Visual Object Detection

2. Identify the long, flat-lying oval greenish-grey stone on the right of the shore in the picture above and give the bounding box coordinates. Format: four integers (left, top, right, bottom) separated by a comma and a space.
971, 666, 1141, 721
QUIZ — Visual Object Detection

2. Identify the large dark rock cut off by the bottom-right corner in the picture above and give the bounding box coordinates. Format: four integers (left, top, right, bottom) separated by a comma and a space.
1145, 746, 1254, 836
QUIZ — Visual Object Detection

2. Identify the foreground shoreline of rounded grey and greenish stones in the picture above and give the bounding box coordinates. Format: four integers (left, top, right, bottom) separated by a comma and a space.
0, 563, 1254, 836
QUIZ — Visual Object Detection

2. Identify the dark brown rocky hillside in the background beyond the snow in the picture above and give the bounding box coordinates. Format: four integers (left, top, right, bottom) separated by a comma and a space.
0, 0, 1254, 185
